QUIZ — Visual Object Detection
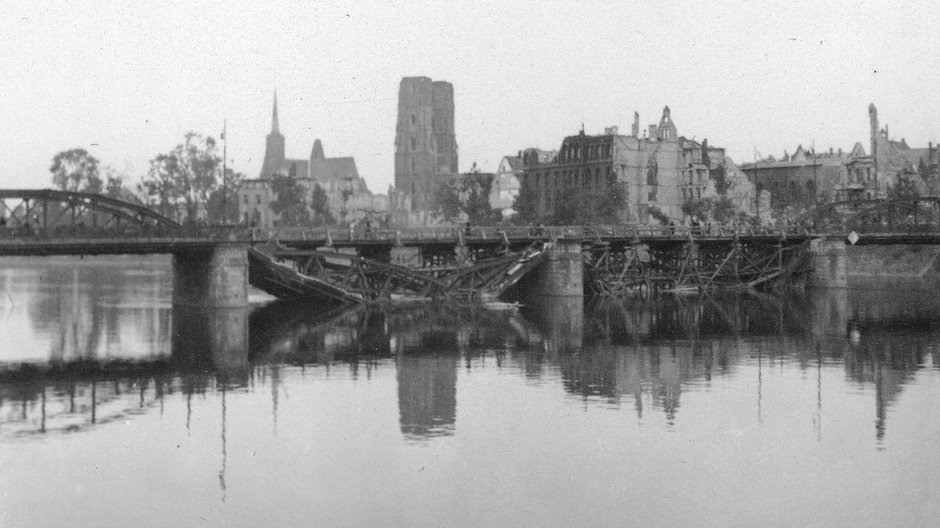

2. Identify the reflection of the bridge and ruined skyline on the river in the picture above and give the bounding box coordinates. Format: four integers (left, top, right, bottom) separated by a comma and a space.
0, 258, 940, 446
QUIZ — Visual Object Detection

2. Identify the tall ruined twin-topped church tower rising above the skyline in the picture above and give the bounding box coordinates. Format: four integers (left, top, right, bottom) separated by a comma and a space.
395, 77, 457, 211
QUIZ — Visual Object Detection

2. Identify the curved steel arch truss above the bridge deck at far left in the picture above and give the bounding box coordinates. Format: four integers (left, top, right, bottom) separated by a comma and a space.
0, 189, 181, 234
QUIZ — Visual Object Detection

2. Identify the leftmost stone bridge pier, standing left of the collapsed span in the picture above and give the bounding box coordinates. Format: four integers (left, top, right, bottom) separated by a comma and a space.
173, 244, 248, 308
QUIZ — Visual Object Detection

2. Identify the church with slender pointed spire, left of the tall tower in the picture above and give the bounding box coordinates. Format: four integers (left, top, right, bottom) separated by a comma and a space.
238, 94, 388, 227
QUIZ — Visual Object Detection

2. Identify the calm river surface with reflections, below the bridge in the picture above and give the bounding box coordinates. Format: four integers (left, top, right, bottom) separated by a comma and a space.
0, 258, 940, 527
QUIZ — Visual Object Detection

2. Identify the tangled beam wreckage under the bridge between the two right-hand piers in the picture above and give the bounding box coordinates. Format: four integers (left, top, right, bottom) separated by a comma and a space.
583, 235, 811, 296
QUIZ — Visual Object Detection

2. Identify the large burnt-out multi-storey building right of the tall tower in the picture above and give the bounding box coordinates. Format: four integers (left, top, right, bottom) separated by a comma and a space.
522, 106, 725, 222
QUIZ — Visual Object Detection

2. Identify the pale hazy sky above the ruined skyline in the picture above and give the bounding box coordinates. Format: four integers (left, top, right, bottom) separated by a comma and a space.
0, 0, 940, 192
